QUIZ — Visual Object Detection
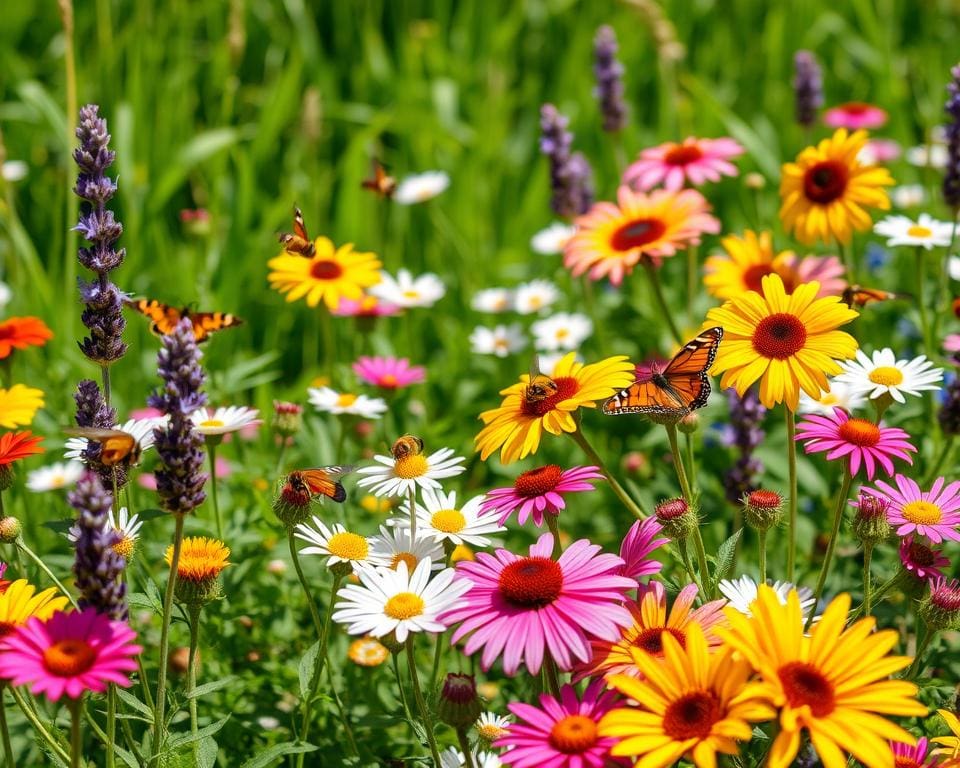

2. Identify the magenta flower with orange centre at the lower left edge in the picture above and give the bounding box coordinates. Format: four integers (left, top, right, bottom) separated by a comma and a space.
0, 608, 143, 701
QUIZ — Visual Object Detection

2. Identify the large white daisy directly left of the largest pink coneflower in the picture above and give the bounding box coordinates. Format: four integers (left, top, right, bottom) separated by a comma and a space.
333, 560, 472, 643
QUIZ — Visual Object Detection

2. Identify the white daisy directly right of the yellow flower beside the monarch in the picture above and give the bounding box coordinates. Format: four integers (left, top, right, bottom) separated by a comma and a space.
835, 347, 943, 403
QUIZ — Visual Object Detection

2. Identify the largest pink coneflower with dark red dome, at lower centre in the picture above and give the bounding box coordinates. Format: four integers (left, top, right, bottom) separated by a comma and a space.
440, 533, 636, 675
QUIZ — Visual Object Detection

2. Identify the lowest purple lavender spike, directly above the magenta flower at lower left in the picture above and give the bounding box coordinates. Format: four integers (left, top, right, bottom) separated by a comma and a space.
67, 472, 127, 620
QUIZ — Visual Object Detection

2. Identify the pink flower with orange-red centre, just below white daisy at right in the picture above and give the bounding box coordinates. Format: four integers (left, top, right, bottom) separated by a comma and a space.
796, 408, 917, 480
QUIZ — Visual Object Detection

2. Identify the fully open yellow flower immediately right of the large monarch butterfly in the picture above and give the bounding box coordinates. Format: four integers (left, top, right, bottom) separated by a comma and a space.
703, 275, 858, 411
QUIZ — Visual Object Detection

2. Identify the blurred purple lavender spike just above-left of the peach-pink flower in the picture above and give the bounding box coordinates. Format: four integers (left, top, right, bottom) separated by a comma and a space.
540, 104, 593, 217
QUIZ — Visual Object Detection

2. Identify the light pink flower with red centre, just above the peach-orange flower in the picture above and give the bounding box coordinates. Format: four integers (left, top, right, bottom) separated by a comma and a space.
623, 136, 743, 192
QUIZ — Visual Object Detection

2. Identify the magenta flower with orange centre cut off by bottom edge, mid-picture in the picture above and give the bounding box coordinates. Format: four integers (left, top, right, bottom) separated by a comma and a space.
493, 680, 621, 768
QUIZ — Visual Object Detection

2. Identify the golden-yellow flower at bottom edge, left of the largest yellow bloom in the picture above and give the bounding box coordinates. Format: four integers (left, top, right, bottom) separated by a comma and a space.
598, 624, 776, 768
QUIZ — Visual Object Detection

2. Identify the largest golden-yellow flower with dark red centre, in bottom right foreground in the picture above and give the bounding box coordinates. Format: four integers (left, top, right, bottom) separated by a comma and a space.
718, 584, 927, 768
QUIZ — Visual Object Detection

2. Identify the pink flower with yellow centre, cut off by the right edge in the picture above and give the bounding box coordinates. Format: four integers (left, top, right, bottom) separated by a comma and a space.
863, 475, 960, 544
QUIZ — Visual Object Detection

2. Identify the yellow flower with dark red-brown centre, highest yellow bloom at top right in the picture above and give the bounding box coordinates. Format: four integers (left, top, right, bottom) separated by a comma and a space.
780, 128, 893, 244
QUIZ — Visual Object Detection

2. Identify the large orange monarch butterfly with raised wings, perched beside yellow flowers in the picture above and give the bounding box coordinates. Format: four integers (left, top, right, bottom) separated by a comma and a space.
601, 327, 723, 418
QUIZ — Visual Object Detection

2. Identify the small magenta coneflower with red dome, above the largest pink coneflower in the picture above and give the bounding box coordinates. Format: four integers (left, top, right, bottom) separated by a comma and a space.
480, 464, 603, 527
